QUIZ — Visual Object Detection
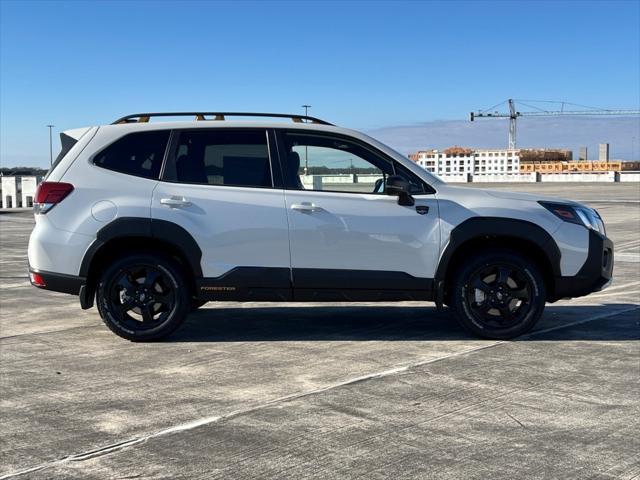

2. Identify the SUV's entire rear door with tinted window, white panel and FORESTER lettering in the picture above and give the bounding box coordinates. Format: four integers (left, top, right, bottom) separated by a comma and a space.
152, 127, 291, 299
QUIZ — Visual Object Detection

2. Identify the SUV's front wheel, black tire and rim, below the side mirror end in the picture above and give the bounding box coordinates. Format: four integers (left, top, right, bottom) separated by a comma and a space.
452, 250, 546, 340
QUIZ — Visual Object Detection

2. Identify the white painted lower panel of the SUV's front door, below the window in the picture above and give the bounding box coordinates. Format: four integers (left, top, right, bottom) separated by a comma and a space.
286, 190, 440, 278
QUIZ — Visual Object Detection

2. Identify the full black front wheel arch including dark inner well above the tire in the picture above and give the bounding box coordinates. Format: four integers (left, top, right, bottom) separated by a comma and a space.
434, 217, 561, 304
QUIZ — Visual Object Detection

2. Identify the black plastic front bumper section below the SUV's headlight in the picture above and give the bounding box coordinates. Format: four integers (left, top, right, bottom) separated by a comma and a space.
550, 230, 613, 301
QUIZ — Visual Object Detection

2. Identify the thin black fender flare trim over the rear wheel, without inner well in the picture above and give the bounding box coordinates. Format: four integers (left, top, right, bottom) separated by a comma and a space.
79, 217, 202, 277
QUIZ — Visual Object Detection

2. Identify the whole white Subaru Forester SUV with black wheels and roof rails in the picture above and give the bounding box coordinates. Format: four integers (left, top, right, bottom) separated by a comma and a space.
29, 112, 613, 341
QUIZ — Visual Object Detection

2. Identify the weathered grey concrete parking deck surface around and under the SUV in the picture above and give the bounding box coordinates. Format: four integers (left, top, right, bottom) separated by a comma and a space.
0, 184, 640, 479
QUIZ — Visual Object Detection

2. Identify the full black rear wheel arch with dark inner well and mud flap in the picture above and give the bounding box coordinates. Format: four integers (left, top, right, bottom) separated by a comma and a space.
79, 217, 203, 308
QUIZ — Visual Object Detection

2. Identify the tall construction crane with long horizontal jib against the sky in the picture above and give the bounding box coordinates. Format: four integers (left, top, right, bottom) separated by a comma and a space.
469, 98, 640, 150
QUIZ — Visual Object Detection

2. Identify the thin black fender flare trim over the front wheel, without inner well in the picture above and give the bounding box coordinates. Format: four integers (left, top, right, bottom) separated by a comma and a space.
434, 217, 561, 285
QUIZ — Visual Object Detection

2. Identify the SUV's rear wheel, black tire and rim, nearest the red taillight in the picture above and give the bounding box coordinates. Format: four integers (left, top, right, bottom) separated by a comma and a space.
96, 253, 191, 342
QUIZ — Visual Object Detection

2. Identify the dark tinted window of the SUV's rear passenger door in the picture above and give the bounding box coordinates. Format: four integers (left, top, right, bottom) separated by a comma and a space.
164, 129, 273, 187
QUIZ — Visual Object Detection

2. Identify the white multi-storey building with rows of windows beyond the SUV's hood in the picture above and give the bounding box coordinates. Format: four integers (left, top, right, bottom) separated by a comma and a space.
409, 147, 520, 175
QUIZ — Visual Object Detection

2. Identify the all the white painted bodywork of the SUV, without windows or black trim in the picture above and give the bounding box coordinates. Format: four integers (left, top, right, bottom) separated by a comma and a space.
29, 117, 588, 278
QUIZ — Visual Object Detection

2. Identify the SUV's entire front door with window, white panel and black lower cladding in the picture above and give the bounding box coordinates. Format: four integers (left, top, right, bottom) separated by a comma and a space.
278, 130, 440, 300
